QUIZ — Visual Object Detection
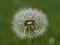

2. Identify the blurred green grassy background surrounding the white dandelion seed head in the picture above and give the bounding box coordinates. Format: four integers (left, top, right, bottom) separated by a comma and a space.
0, 0, 60, 45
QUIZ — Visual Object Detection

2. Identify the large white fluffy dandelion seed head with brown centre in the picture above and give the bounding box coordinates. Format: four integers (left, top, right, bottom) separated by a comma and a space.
12, 8, 48, 39
